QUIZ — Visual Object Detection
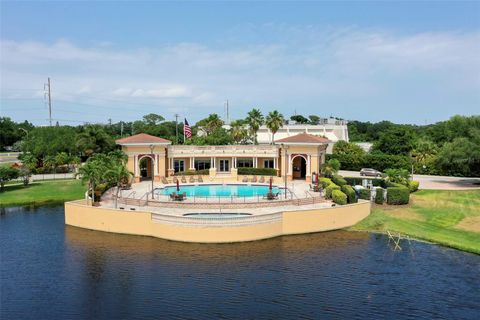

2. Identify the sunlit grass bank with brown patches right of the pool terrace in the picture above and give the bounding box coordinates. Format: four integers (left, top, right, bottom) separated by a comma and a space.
351, 190, 480, 254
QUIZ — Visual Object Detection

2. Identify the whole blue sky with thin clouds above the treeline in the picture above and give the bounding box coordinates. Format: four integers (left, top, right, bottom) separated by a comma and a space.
0, 1, 480, 125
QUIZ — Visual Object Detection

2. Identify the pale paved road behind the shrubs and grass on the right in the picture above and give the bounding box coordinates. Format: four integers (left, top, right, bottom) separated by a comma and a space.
339, 170, 480, 190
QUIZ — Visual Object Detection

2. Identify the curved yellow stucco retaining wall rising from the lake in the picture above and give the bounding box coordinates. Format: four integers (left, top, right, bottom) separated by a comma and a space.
65, 201, 370, 243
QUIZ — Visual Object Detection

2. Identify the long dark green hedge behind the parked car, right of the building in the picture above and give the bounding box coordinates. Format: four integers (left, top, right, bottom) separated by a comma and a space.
326, 153, 411, 171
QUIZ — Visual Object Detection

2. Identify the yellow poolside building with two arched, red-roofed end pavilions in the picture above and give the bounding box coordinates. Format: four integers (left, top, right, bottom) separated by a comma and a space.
116, 133, 329, 182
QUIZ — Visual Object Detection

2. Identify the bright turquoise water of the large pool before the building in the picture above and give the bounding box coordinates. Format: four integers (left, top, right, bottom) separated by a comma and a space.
157, 184, 279, 197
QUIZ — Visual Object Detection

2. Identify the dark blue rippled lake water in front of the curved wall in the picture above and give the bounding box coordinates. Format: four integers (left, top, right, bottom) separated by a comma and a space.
0, 206, 480, 320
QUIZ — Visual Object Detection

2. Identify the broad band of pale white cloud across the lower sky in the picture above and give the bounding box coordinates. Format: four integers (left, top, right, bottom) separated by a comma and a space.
0, 25, 480, 124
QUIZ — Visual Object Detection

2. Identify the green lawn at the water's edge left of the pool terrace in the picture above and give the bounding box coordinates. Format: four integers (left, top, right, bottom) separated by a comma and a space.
0, 180, 86, 207
